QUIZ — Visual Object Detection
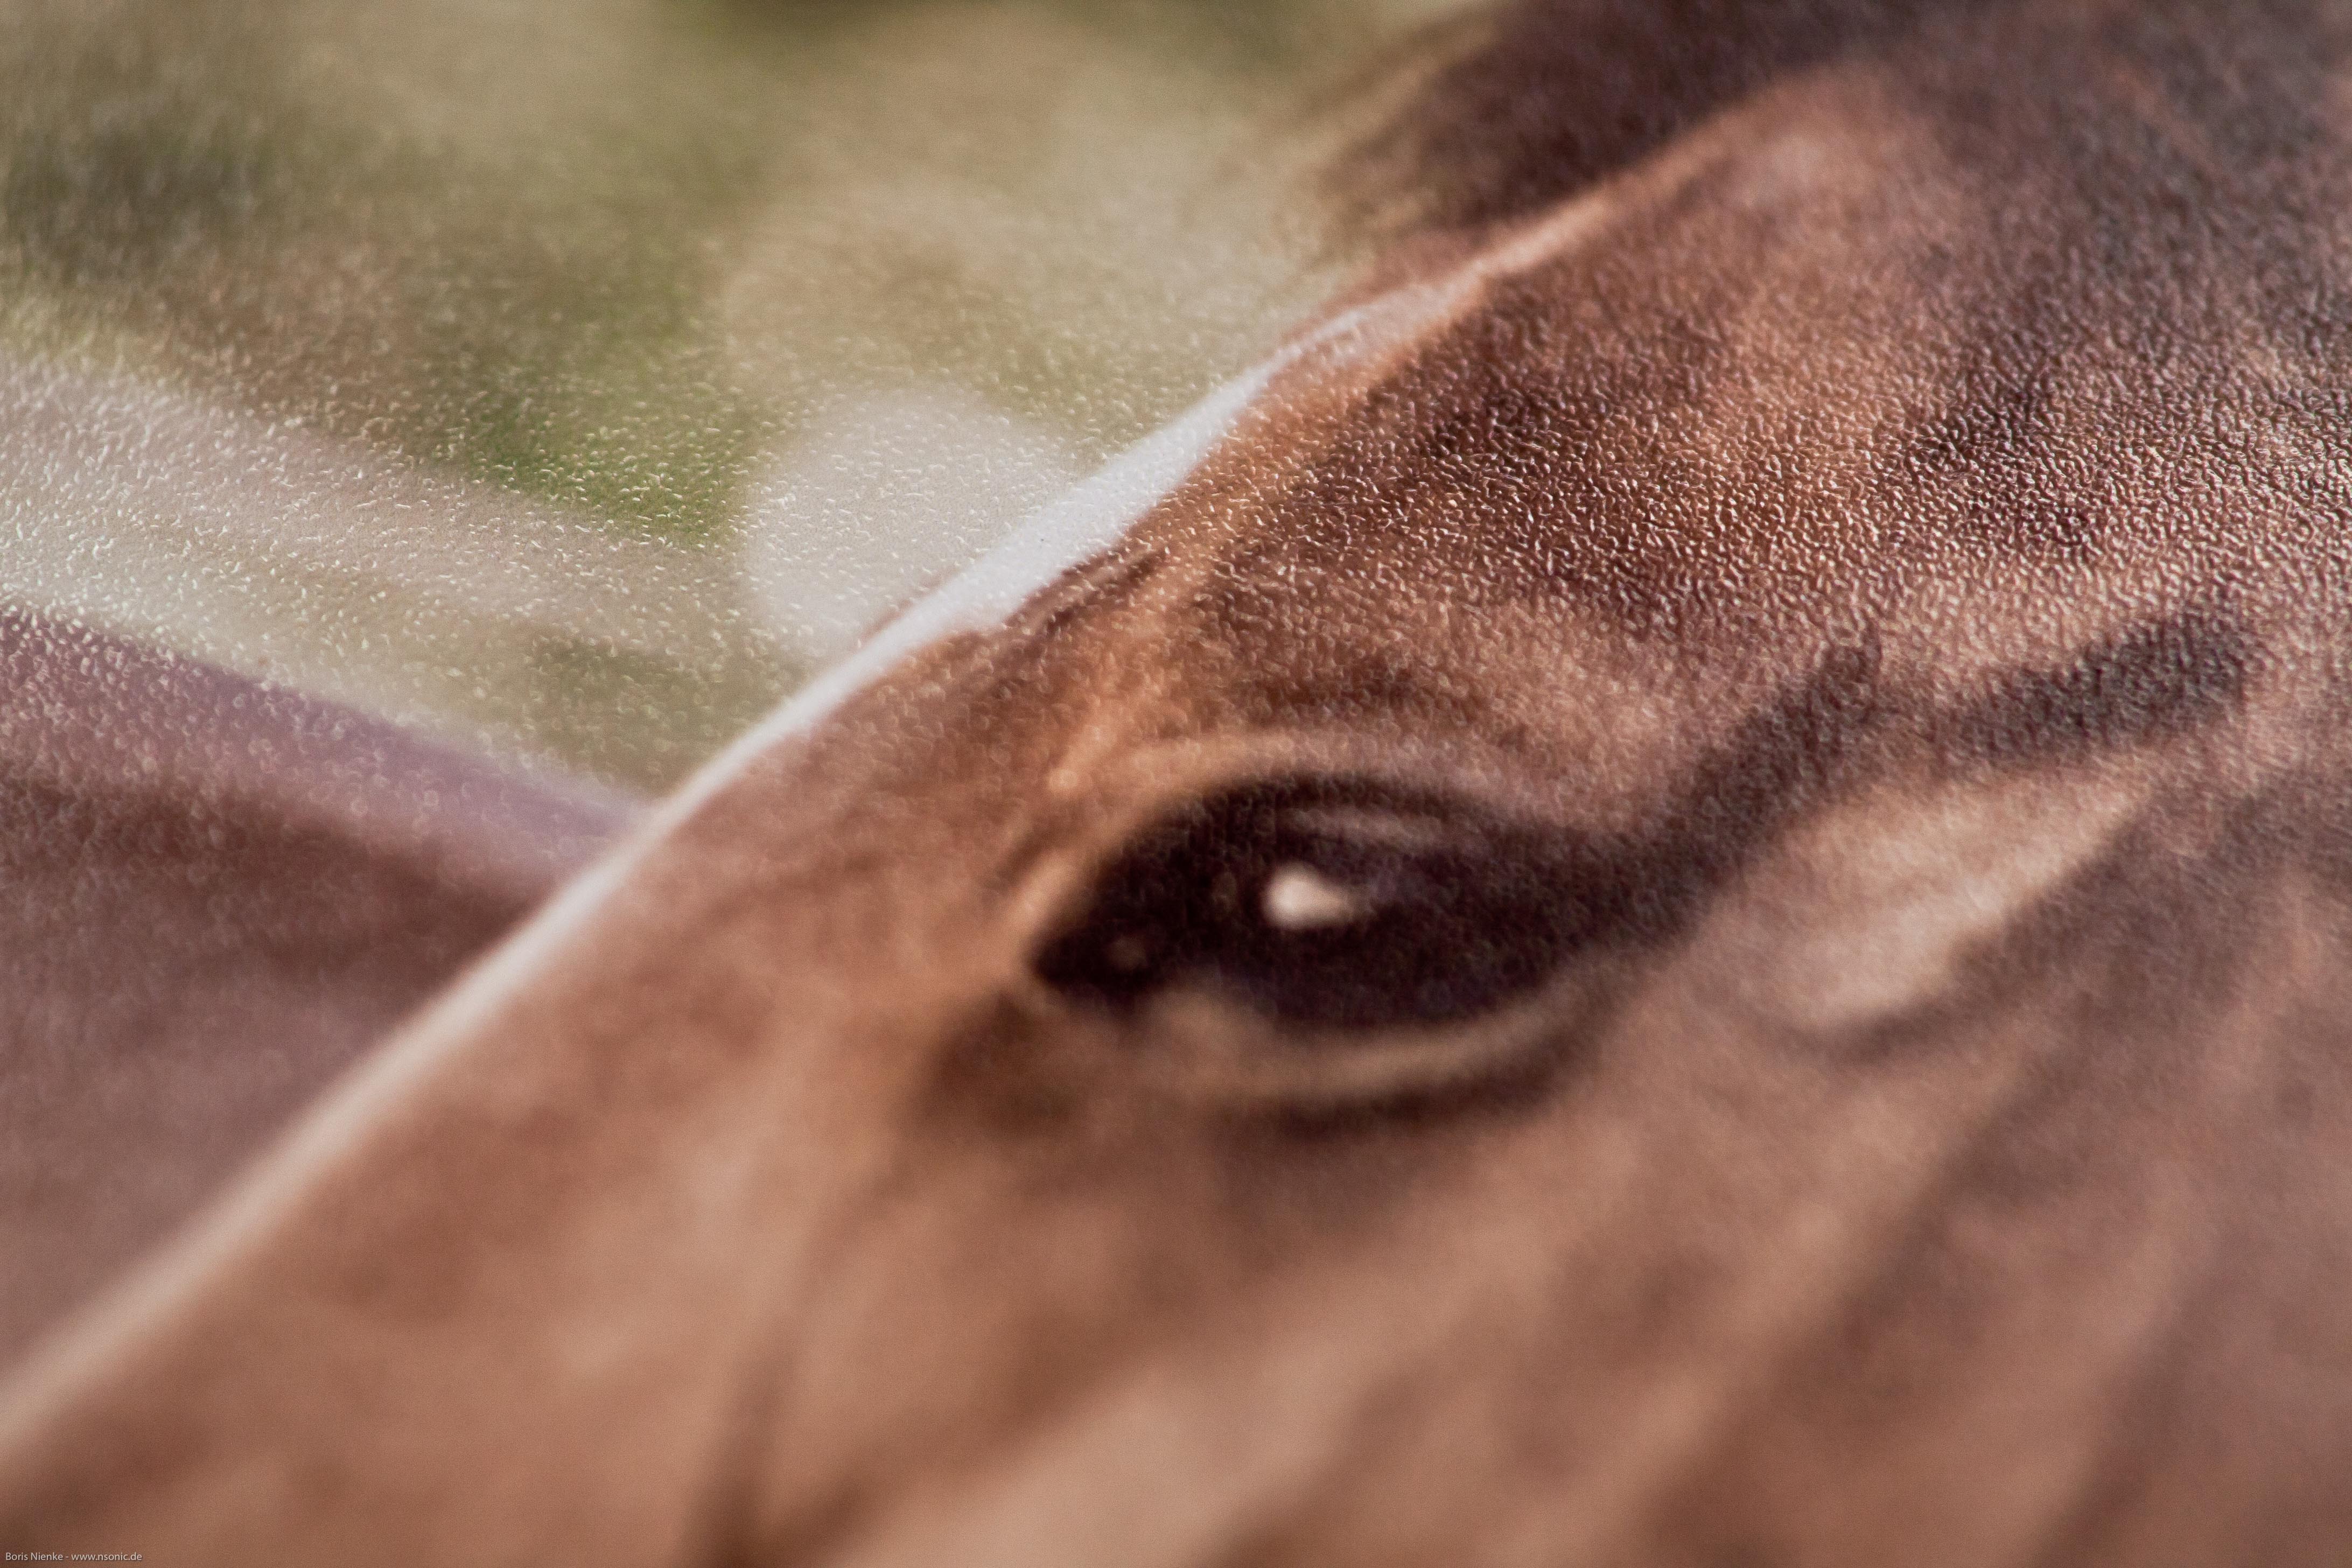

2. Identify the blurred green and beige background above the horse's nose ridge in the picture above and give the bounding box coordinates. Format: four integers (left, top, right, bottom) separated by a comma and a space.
0, 0, 1453, 790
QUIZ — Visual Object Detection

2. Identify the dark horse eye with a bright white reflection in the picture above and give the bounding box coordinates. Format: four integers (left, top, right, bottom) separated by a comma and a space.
1037, 788, 1625, 1027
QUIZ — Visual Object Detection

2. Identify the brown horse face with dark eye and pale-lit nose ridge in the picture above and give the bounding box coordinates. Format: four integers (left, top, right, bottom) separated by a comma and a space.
13, 6, 2352, 1568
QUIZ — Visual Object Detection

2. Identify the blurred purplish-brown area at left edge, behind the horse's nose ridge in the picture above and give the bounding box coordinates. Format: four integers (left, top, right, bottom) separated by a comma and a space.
0, 611, 624, 1359
